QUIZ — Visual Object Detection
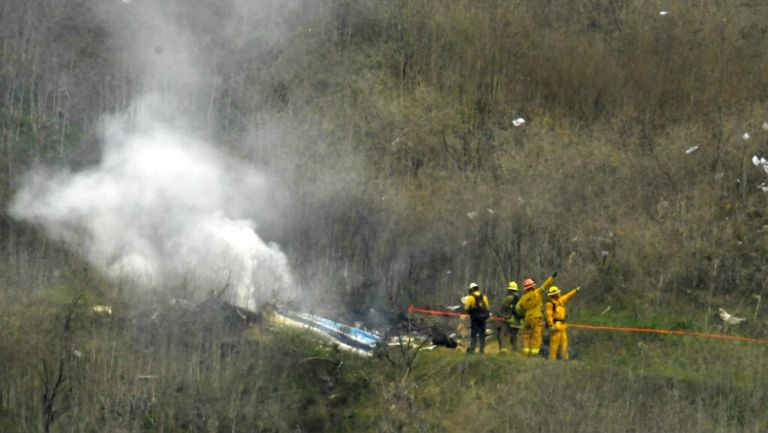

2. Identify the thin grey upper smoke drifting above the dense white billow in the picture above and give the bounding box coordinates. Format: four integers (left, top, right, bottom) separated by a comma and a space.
91, 0, 305, 98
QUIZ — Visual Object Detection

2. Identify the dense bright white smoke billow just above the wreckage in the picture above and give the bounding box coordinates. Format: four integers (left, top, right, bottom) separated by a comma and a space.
11, 96, 293, 309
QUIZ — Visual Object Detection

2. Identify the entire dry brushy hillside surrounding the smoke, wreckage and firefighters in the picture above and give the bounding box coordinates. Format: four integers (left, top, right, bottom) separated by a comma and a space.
0, 0, 768, 433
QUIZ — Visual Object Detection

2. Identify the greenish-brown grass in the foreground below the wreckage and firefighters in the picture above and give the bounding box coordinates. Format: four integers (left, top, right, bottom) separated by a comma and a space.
0, 292, 768, 433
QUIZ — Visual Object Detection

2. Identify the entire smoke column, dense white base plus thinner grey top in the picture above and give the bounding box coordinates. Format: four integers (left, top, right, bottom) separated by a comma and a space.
10, 0, 306, 309
